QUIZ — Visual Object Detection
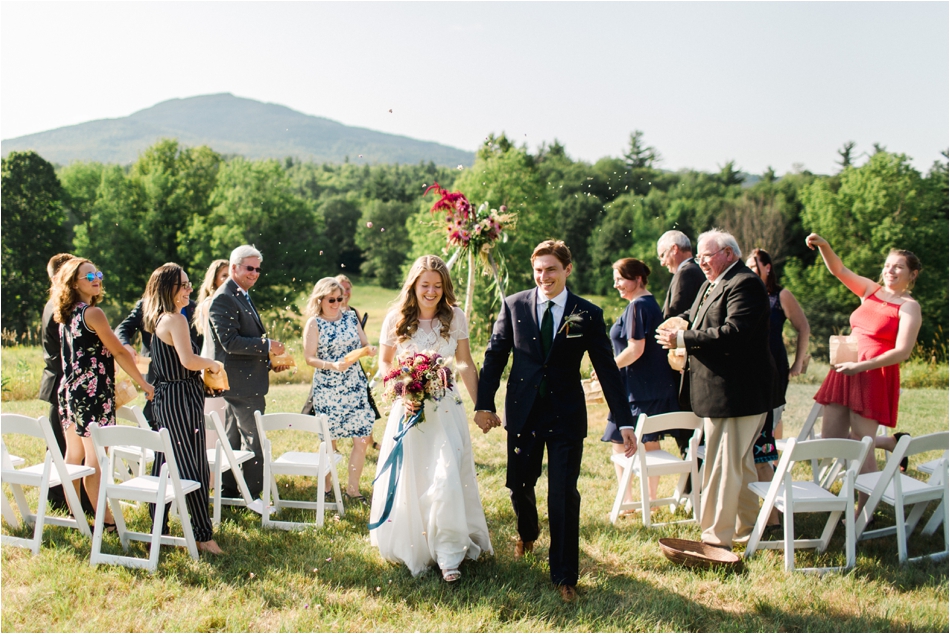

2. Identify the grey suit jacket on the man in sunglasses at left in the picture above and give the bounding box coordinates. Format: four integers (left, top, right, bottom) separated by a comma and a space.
208, 279, 270, 397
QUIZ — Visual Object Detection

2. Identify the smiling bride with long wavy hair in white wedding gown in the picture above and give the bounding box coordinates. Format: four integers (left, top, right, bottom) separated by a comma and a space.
370, 255, 492, 583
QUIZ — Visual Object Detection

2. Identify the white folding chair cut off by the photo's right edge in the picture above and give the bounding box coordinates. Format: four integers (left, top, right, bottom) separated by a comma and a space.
854, 431, 950, 563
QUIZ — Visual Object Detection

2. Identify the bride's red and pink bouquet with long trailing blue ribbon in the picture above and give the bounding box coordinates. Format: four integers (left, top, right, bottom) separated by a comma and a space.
369, 351, 452, 530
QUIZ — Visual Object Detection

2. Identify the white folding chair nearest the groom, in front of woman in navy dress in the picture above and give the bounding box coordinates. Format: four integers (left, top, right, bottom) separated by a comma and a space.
610, 412, 703, 528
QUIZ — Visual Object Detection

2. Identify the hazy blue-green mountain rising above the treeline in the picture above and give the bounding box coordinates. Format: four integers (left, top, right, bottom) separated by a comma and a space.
0, 93, 475, 167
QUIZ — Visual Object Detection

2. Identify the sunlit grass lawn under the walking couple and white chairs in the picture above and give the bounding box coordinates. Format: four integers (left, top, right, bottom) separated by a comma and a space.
0, 378, 948, 632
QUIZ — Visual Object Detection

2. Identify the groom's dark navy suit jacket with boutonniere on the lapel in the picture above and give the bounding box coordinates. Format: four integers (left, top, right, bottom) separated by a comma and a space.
475, 289, 636, 438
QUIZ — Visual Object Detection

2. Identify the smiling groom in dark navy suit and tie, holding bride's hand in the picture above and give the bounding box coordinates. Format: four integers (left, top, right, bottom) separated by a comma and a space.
475, 240, 637, 602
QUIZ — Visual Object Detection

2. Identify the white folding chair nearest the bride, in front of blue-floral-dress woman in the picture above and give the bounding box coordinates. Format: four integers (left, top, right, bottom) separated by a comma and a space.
254, 412, 343, 530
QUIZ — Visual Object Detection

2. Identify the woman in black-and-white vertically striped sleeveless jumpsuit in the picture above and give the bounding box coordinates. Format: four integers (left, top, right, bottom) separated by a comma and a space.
142, 263, 222, 555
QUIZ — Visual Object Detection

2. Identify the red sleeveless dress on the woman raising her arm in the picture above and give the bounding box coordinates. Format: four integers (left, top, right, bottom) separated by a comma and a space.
815, 294, 901, 427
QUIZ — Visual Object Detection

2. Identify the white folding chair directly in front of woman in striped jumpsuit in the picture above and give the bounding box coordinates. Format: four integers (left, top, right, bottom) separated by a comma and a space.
90, 424, 201, 571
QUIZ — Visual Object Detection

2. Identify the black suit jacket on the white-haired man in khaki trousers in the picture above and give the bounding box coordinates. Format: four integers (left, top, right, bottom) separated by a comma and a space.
680, 260, 775, 418
